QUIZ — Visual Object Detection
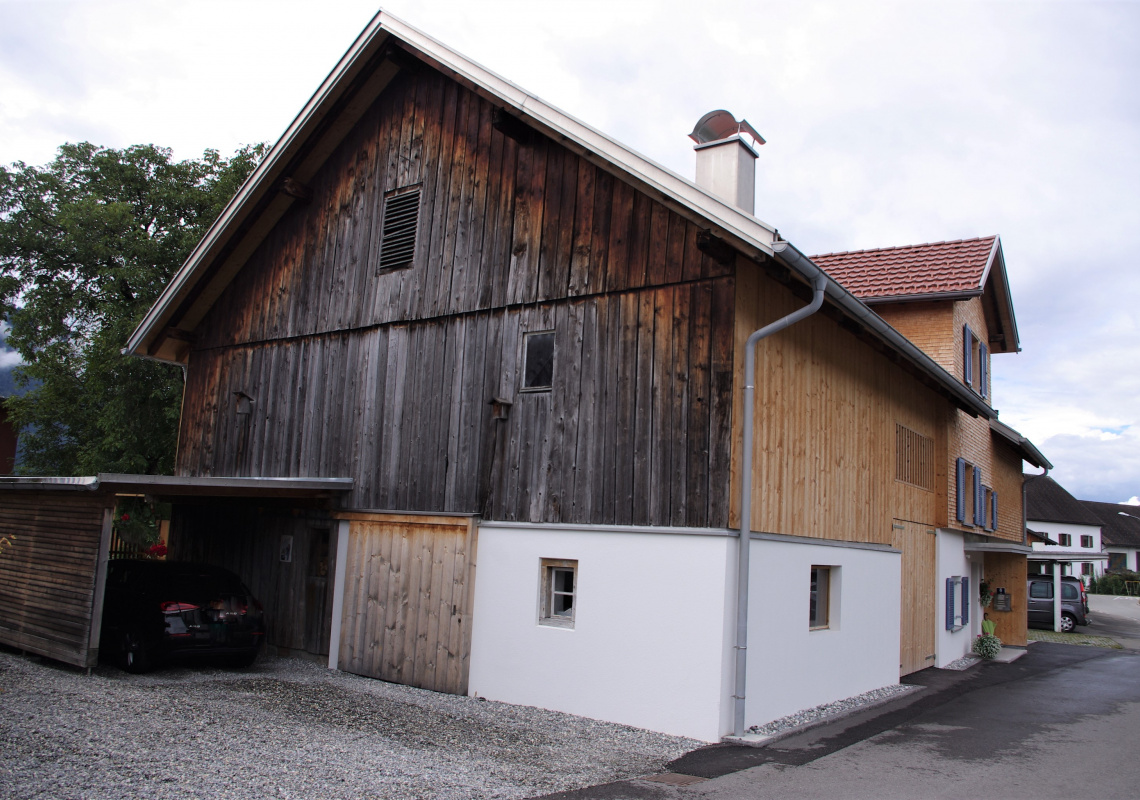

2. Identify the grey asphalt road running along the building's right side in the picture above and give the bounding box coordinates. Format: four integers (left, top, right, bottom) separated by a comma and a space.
538, 643, 1140, 800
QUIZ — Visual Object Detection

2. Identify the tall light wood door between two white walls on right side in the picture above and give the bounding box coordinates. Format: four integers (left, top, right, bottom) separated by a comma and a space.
891, 520, 938, 676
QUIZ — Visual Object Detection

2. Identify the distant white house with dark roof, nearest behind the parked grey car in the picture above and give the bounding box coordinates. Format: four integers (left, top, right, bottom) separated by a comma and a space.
1025, 475, 1108, 582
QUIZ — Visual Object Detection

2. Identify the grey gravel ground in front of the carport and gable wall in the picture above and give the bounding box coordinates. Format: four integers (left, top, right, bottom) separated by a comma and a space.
0, 651, 703, 800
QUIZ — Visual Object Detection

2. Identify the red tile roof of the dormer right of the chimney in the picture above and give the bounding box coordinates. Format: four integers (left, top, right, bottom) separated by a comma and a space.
812, 236, 998, 299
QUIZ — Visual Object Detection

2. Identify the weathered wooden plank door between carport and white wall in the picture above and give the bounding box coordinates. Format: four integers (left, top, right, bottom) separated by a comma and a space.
339, 514, 477, 694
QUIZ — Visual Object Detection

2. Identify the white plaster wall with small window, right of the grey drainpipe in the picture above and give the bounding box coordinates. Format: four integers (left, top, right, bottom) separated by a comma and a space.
743, 537, 901, 726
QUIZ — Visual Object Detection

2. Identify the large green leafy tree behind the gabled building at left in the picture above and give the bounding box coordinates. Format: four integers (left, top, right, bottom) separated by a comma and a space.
0, 142, 266, 475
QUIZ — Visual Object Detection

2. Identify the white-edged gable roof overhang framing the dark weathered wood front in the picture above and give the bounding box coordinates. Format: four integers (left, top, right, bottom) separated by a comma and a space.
125, 11, 995, 419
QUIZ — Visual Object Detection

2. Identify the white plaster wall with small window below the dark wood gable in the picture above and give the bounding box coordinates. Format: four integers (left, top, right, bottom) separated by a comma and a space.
469, 523, 734, 741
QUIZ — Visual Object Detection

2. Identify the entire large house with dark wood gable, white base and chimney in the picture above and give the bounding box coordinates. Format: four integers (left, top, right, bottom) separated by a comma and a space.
0, 14, 1048, 741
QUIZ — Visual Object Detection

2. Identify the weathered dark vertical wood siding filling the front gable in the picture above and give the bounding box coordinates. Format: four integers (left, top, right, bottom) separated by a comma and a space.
179, 68, 735, 525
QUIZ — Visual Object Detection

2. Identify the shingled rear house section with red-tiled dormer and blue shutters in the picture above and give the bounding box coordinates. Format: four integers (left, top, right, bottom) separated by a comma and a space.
812, 236, 1051, 667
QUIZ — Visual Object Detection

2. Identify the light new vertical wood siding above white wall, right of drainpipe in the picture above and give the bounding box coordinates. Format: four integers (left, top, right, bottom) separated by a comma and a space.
730, 264, 950, 544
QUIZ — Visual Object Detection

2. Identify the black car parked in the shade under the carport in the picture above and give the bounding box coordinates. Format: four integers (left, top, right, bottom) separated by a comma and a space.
99, 558, 266, 672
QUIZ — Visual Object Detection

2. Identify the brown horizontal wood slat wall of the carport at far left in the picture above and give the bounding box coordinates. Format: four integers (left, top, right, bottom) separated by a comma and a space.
0, 491, 115, 667
